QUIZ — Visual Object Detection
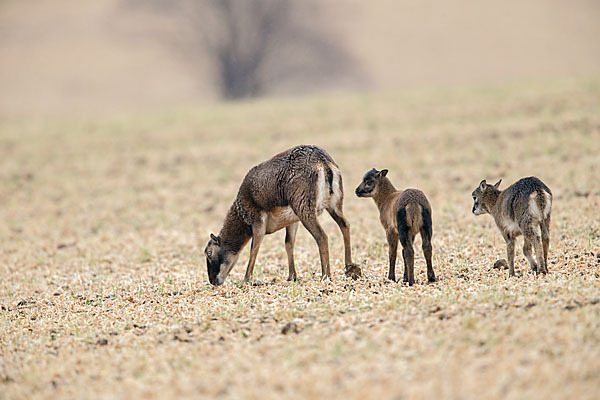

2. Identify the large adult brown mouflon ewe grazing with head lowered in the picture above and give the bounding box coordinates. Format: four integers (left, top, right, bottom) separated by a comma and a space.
204, 145, 360, 285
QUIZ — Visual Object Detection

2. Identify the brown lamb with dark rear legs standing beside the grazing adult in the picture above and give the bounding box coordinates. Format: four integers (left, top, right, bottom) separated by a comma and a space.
355, 168, 436, 286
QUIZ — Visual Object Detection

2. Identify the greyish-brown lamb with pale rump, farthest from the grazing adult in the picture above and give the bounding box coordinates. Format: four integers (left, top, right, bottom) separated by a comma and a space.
472, 176, 552, 276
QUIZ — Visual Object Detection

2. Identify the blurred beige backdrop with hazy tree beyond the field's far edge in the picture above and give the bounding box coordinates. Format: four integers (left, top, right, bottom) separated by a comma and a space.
0, 0, 600, 117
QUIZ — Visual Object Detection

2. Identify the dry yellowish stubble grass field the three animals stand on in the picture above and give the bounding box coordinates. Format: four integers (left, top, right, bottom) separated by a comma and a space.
0, 79, 600, 399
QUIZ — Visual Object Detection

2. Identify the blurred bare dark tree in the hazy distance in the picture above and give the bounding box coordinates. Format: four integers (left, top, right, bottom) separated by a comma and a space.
120, 0, 358, 99
